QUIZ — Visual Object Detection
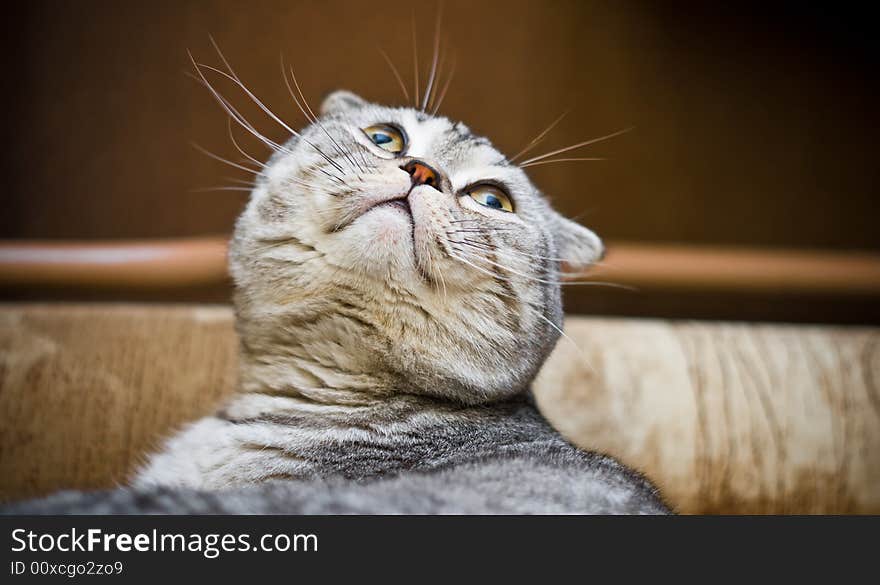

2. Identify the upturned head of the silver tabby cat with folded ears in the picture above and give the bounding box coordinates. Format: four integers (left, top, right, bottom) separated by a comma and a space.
231, 92, 601, 403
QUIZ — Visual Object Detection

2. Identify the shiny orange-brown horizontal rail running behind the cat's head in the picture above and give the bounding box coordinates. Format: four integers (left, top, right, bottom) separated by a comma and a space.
0, 237, 880, 297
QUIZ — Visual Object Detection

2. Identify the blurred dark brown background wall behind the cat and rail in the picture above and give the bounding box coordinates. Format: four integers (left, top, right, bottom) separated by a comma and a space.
0, 0, 880, 322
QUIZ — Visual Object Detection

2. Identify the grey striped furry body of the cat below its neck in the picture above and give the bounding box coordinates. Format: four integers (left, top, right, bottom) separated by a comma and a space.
9, 398, 666, 514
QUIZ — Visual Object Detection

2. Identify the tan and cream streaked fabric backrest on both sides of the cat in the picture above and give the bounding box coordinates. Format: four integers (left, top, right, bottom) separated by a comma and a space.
0, 305, 880, 513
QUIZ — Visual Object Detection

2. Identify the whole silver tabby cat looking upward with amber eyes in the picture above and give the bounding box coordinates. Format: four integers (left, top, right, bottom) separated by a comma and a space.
3, 65, 670, 514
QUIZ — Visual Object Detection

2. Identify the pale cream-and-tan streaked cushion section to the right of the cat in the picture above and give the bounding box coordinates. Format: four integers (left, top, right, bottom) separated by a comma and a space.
537, 318, 880, 514
